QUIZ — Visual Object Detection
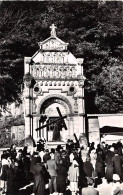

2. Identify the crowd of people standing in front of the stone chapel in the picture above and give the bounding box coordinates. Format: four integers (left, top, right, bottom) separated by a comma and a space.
0, 137, 123, 195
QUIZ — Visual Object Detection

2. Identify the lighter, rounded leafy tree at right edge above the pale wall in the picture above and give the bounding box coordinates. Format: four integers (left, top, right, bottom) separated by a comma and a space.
95, 58, 123, 113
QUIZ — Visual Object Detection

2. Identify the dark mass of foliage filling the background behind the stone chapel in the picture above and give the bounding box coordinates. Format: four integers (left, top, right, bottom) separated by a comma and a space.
0, 1, 123, 113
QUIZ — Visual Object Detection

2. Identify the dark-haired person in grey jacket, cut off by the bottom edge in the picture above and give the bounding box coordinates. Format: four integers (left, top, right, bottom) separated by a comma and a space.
82, 178, 99, 195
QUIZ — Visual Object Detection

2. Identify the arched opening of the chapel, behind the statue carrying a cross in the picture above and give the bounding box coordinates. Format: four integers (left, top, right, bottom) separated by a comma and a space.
39, 97, 71, 141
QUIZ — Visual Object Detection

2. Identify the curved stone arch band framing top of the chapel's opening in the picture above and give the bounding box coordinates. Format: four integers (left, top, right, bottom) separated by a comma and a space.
37, 94, 73, 114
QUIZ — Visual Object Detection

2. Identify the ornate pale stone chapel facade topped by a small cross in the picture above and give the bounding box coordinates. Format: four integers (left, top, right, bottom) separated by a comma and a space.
24, 24, 85, 142
